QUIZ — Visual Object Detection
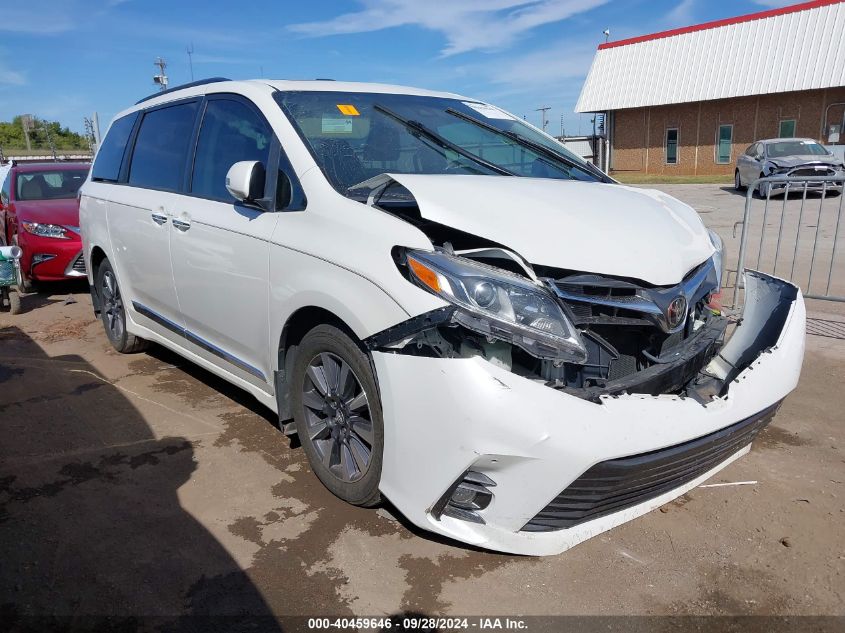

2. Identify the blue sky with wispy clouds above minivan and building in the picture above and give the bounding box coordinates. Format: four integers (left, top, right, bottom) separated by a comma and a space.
0, 0, 794, 134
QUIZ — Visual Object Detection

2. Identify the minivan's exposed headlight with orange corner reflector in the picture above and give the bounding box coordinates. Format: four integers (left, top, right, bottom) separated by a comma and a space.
408, 251, 587, 364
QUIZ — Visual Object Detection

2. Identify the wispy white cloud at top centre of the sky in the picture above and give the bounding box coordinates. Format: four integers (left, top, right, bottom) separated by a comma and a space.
289, 0, 609, 56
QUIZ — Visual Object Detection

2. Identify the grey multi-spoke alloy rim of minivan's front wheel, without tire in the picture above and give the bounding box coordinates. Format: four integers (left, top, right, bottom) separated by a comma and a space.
302, 352, 374, 482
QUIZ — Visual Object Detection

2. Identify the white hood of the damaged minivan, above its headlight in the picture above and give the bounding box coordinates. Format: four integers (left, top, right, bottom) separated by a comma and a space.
388, 174, 714, 286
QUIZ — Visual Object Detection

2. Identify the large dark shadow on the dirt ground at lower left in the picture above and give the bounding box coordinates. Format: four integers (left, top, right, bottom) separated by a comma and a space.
0, 328, 280, 630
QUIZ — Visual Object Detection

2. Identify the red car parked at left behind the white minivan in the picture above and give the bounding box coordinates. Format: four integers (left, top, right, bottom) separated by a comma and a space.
0, 162, 91, 286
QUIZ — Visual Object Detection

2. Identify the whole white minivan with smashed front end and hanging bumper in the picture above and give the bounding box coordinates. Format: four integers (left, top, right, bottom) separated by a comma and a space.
80, 79, 805, 555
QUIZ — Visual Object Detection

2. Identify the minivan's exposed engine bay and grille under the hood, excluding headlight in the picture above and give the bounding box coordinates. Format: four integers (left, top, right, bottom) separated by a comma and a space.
366, 180, 792, 402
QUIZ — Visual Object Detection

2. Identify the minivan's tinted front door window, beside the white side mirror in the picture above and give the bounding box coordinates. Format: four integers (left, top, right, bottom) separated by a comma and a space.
191, 99, 272, 202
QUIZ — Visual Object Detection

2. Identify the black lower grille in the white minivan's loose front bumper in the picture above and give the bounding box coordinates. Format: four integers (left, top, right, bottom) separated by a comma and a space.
522, 402, 780, 532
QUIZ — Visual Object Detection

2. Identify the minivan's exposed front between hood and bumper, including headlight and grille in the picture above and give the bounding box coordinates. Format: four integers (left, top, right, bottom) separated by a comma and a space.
366, 245, 784, 402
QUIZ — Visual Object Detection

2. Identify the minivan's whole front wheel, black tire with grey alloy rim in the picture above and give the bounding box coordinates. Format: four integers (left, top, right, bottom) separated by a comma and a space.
291, 325, 384, 507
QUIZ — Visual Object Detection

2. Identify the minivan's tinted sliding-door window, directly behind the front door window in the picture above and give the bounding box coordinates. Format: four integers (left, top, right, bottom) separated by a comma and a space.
129, 101, 197, 191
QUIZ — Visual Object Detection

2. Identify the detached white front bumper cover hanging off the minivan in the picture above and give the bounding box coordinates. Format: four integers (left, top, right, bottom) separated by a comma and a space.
373, 271, 805, 555
